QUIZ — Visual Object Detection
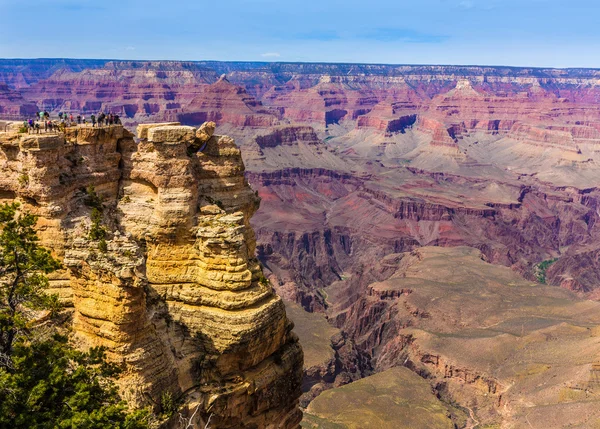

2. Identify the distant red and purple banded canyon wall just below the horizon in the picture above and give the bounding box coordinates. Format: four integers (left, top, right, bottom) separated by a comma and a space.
8, 59, 600, 143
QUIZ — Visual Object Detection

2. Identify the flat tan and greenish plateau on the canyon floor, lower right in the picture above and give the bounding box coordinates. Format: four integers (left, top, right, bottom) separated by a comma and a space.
298, 247, 600, 428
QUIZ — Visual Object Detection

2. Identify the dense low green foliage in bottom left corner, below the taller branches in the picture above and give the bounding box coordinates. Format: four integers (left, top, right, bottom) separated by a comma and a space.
0, 335, 150, 429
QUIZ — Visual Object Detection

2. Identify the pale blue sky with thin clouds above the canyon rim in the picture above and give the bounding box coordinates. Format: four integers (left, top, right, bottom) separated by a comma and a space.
0, 0, 600, 68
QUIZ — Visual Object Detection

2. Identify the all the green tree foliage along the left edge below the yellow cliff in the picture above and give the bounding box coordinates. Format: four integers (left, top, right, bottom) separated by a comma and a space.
0, 204, 149, 429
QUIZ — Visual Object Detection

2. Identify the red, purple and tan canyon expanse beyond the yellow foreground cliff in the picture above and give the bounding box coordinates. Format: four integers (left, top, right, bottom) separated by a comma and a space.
0, 60, 600, 429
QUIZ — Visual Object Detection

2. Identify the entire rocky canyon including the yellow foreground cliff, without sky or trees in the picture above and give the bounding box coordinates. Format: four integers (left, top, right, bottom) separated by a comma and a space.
0, 59, 600, 429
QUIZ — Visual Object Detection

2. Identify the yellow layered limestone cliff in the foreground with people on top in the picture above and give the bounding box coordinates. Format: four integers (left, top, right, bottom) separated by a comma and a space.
0, 124, 302, 428
